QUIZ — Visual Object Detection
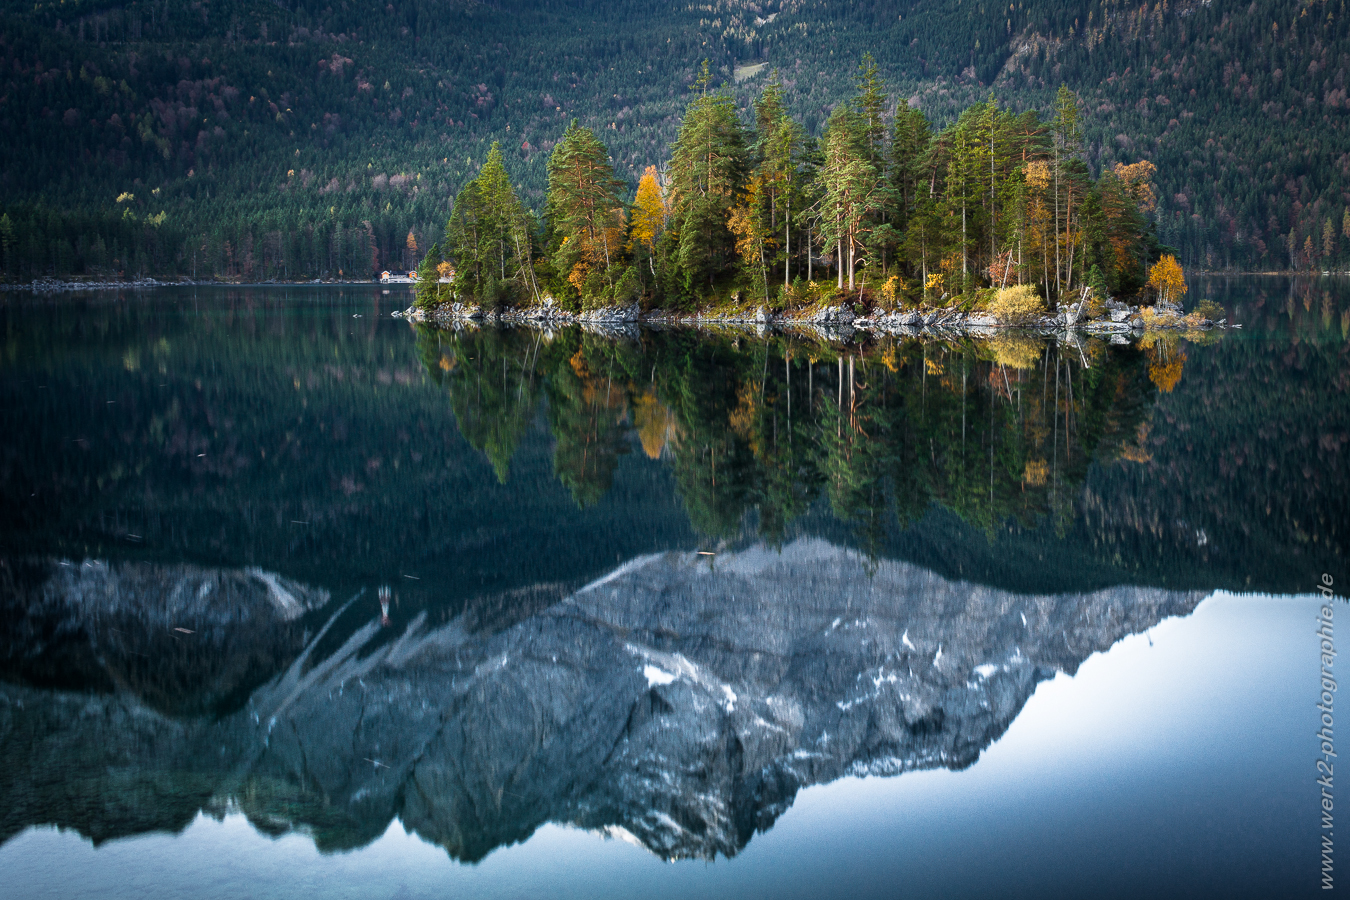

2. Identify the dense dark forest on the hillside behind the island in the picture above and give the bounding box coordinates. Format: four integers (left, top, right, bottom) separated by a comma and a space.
0, 0, 1350, 281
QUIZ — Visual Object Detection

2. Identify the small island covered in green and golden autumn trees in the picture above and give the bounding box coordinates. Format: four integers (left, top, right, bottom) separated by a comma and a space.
416, 55, 1219, 324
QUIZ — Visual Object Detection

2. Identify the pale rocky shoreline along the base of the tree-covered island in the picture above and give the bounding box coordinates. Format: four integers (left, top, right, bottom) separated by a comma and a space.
393, 298, 1241, 341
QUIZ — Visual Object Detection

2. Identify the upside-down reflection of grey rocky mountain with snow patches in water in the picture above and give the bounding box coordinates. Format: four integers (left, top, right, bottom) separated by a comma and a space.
0, 538, 1200, 861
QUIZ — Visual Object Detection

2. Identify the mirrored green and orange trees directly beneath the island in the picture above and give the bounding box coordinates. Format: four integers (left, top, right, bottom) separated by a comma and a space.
419, 329, 1156, 548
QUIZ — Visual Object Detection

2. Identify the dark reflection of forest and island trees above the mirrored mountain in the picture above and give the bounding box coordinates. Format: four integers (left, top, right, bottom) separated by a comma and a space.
0, 296, 1350, 604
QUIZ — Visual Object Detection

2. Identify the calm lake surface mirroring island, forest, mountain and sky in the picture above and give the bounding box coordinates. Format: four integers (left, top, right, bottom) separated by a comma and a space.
0, 277, 1350, 897
